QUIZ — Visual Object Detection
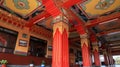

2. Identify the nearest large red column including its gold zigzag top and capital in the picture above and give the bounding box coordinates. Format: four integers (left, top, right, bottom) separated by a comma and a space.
52, 15, 69, 67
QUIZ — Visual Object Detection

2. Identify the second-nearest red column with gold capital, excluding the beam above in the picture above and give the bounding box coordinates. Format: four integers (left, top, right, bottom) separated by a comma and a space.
80, 34, 91, 67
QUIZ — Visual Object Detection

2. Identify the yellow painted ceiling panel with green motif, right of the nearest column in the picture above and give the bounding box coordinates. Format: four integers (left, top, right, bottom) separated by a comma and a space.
78, 0, 120, 18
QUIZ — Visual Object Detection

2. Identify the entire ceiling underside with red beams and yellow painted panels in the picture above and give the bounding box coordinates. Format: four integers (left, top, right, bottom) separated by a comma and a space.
0, 0, 120, 55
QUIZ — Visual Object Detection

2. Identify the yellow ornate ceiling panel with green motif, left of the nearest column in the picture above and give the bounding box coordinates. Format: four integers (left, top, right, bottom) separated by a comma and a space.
1, 0, 42, 17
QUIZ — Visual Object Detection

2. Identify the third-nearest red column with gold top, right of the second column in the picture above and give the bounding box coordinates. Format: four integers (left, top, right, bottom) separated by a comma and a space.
92, 42, 101, 66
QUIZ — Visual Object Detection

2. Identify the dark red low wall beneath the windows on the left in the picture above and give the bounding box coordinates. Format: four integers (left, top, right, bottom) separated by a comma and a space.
0, 53, 52, 65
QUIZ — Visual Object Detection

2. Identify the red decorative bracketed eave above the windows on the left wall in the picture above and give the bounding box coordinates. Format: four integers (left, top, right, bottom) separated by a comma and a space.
0, 10, 52, 38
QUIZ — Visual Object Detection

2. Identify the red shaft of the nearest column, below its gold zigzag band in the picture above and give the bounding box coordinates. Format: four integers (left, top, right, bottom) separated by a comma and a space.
52, 29, 69, 67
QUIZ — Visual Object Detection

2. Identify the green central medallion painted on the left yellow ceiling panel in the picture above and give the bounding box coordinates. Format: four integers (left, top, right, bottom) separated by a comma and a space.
13, 0, 30, 9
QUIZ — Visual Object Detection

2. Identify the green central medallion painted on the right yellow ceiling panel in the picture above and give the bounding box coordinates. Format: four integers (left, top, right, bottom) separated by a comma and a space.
95, 0, 115, 10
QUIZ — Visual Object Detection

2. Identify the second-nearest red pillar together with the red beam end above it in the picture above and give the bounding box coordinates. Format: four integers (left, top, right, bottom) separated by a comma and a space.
75, 24, 92, 67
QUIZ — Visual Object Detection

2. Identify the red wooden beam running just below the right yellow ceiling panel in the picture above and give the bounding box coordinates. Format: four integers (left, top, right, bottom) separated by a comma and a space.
85, 12, 120, 27
